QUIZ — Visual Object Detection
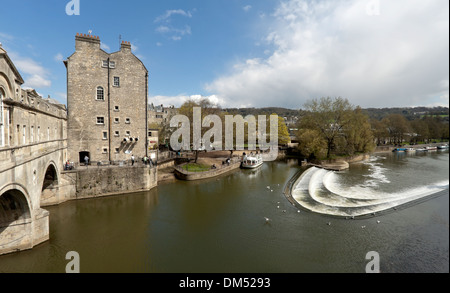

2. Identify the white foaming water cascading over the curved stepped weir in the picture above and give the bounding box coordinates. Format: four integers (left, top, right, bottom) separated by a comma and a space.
292, 161, 449, 216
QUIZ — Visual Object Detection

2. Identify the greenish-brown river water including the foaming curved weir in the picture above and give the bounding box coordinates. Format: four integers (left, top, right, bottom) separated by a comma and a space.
0, 151, 449, 273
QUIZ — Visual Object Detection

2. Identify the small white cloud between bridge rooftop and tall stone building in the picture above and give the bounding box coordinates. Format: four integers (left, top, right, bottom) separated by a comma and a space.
9, 52, 52, 88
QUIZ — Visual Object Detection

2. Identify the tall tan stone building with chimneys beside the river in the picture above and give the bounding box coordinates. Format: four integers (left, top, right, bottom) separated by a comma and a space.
64, 34, 148, 163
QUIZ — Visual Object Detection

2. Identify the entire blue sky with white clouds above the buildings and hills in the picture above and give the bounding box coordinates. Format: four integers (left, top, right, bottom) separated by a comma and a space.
0, 0, 449, 108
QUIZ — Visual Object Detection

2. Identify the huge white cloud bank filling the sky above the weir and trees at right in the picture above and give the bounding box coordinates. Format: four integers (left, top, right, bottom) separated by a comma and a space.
205, 0, 449, 108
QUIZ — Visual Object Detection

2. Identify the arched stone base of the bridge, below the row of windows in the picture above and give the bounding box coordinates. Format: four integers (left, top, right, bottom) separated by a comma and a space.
0, 140, 71, 255
